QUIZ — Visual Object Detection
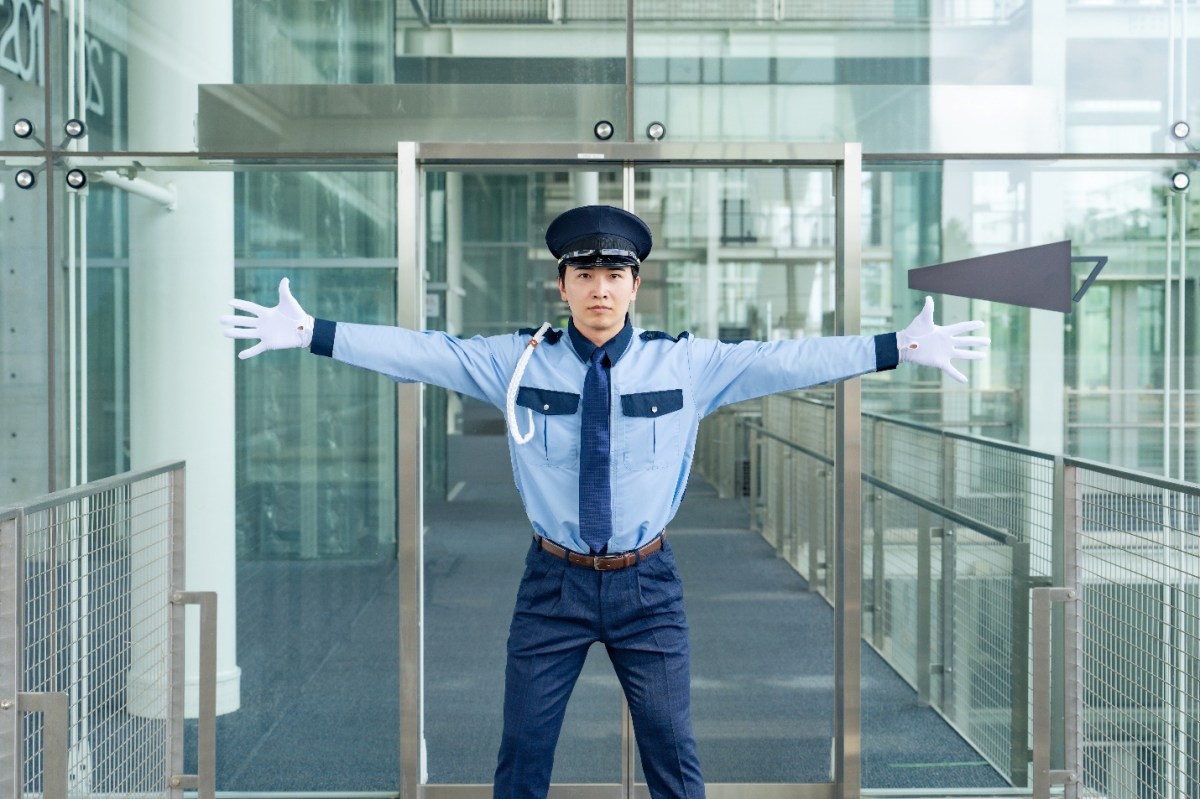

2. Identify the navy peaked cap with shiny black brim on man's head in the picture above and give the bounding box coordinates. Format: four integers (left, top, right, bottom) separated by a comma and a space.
546, 205, 653, 266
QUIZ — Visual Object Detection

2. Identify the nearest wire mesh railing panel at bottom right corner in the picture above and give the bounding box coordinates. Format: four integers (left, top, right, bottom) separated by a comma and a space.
1074, 463, 1200, 797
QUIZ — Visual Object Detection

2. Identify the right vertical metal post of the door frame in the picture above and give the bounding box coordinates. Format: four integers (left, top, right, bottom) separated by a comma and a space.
833, 144, 863, 799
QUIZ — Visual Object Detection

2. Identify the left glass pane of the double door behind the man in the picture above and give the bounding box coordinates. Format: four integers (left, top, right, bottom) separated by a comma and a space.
424, 169, 622, 785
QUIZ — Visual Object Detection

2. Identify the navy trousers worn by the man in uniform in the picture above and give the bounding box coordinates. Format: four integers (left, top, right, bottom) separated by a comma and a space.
492, 541, 704, 799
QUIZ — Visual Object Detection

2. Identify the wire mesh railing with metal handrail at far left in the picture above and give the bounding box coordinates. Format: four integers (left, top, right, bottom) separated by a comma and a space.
0, 461, 196, 799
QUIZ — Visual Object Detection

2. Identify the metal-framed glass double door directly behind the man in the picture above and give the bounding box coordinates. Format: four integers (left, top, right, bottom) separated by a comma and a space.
398, 144, 859, 797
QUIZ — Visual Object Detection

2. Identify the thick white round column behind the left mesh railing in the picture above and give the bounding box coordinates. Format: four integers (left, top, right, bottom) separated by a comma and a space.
128, 0, 241, 716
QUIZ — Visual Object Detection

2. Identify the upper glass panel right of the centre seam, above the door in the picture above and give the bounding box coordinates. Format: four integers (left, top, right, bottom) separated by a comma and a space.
633, 0, 1198, 152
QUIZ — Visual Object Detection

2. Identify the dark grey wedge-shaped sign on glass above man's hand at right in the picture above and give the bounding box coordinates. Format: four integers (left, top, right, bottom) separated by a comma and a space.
908, 240, 1109, 313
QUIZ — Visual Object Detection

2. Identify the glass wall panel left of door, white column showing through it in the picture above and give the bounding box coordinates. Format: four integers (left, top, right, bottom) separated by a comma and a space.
63, 163, 400, 792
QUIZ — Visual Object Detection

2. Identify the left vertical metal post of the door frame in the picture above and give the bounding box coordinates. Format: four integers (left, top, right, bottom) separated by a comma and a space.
396, 142, 425, 799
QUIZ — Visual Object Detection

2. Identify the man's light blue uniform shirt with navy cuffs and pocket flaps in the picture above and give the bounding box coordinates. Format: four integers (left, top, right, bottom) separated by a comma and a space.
312, 319, 898, 553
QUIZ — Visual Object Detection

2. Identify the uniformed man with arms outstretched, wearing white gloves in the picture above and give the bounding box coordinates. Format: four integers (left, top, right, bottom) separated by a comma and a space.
222, 205, 990, 799
